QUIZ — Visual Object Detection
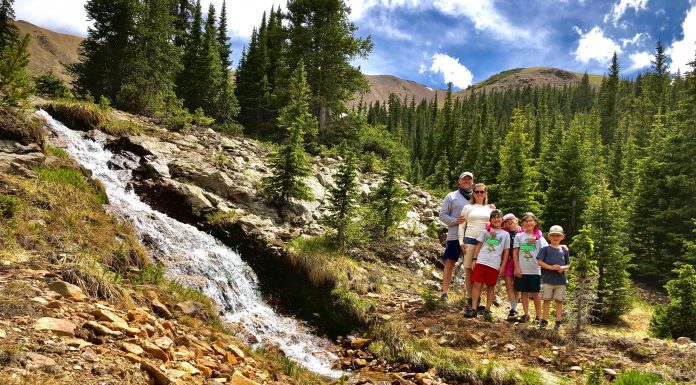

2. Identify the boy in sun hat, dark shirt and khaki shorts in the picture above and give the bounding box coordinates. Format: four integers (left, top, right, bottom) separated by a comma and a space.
537, 225, 570, 329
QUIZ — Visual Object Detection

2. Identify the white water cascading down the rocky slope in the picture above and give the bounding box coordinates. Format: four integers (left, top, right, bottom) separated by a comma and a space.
38, 110, 341, 377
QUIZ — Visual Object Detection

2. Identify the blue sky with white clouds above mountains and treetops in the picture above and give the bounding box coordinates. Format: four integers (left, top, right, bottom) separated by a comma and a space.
15, 0, 696, 88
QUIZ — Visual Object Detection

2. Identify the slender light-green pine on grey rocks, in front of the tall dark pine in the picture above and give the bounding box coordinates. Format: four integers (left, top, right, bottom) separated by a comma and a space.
263, 63, 317, 205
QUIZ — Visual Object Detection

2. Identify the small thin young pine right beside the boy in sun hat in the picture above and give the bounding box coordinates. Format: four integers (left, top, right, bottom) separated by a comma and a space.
570, 228, 597, 334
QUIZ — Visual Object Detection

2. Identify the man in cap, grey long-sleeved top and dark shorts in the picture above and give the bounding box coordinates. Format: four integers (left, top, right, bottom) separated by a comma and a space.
440, 171, 474, 302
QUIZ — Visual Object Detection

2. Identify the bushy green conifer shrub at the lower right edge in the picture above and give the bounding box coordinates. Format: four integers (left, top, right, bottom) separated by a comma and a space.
650, 265, 696, 339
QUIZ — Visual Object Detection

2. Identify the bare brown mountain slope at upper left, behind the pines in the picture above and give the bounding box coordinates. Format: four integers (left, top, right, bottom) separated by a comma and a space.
15, 20, 83, 81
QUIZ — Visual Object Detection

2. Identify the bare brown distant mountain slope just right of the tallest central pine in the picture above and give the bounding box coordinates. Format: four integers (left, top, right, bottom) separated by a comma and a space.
351, 75, 447, 105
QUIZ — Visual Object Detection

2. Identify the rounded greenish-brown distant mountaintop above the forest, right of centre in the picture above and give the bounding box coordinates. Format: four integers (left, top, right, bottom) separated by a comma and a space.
455, 67, 602, 97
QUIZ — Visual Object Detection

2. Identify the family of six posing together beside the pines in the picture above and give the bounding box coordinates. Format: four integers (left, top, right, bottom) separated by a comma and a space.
440, 171, 570, 329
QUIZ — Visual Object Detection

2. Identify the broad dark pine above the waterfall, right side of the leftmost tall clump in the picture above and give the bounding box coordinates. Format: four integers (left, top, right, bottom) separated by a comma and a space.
115, 0, 181, 116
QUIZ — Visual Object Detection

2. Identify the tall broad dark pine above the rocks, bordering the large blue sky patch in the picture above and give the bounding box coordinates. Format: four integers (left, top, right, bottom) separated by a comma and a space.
285, 0, 372, 138
